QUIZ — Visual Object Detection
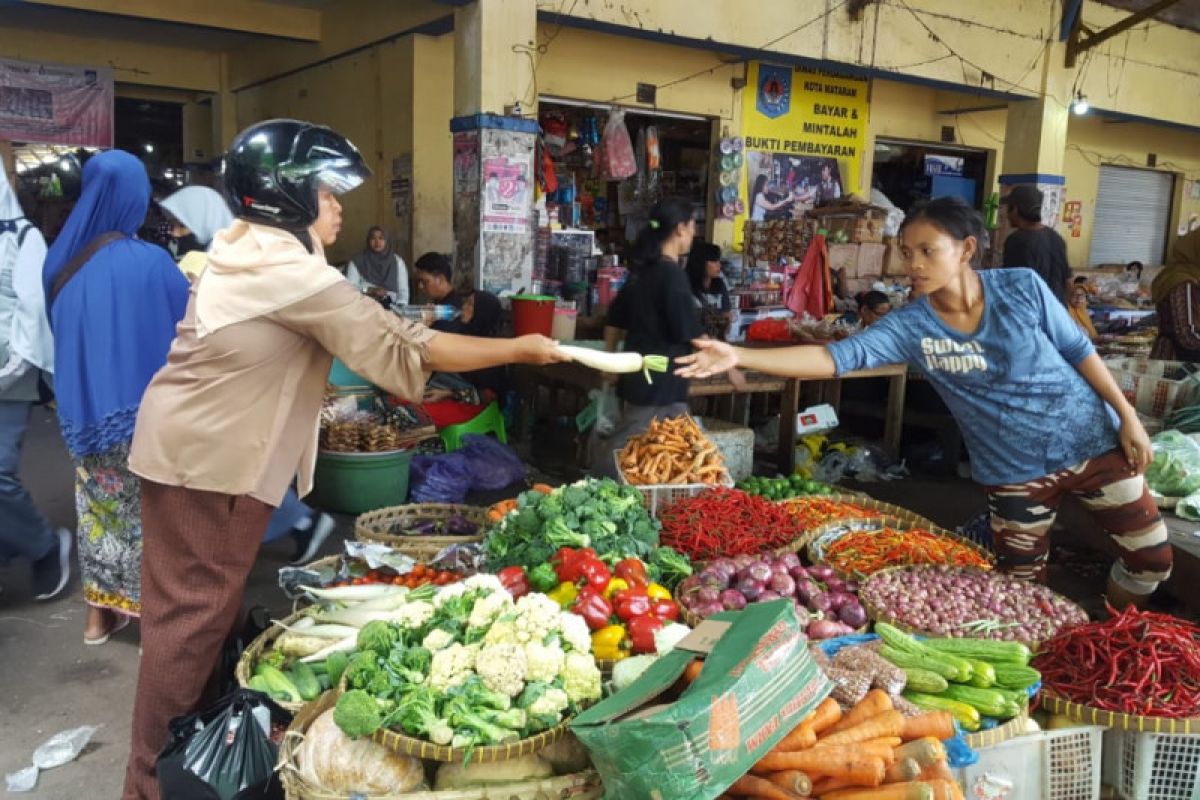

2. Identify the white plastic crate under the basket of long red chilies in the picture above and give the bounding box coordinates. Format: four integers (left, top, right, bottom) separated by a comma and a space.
1104, 728, 1200, 800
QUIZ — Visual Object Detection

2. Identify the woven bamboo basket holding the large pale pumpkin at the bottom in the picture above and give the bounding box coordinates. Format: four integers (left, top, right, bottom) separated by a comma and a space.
276, 692, 604, 800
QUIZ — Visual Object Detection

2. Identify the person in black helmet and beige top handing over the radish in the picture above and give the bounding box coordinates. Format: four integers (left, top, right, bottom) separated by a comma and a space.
122, 120, 565, 800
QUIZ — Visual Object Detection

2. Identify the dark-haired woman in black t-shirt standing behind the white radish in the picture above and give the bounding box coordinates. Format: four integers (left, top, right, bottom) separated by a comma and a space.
593, 198, 703, 475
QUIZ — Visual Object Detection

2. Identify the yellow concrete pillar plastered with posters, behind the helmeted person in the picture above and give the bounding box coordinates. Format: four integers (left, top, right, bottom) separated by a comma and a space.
450, 0, 538, 293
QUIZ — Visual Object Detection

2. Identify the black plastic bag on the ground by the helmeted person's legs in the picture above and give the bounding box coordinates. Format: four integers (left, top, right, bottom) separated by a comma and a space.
155, 688, 292, 800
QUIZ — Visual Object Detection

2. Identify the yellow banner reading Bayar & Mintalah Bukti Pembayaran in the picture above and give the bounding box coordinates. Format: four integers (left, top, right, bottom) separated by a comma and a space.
734, 61, 869, 247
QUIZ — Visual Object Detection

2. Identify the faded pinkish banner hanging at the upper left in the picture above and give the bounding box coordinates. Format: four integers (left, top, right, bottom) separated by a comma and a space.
0, 59, 113, 148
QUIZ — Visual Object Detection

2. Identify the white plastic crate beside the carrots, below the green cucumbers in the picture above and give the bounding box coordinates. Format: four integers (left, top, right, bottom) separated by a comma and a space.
954, 726, 1104, 800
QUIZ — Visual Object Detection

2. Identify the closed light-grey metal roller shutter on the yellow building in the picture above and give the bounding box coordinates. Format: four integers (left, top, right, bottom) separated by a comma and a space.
1088, 166, 1175, 266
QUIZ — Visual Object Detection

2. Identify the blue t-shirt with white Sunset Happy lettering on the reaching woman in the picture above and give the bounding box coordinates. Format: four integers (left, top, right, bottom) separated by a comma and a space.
829, 269, 1117, 486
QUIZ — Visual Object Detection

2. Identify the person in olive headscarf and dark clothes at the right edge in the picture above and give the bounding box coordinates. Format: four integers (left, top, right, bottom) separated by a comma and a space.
1150, 228, 1200, 361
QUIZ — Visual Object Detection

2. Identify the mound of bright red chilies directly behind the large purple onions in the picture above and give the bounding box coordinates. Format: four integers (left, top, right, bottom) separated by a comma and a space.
659, 488, 804, 561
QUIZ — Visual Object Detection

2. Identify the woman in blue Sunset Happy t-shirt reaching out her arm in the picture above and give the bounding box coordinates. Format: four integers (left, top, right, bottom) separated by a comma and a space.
679, 197, 1171, 607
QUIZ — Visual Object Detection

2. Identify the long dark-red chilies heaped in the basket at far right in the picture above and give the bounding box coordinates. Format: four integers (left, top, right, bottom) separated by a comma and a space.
1031, 607, 1200, 720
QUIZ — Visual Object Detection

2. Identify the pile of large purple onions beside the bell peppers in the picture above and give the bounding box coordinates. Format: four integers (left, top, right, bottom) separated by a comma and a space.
677, 553, 866, 639
